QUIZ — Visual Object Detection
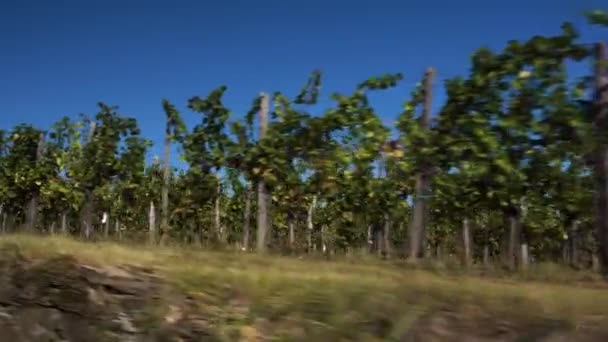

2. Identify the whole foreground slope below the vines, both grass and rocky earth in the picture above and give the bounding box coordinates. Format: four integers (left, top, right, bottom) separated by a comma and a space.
0, 236, 608, 342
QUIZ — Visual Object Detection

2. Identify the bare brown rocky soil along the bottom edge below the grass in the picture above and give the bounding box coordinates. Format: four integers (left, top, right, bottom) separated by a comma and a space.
0, 242, 608, 342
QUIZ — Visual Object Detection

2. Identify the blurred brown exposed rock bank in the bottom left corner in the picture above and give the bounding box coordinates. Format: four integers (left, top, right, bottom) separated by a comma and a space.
0, 247, 216, 342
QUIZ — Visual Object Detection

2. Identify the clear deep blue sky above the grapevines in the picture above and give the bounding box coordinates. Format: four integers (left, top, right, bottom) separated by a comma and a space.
0, 0, 608, 162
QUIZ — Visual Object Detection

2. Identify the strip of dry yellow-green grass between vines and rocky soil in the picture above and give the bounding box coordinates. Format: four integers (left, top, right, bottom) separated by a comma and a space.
0, 236, 608, 341
